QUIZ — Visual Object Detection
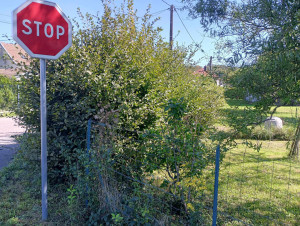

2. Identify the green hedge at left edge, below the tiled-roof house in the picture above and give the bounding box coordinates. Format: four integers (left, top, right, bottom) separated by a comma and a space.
0, 75, 18, 110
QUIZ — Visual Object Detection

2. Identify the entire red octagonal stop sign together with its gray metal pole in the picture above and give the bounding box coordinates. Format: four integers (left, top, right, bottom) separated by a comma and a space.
12, 0, 72, 221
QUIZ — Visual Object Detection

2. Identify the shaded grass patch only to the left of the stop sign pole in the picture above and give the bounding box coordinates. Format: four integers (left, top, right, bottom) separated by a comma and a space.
0, 162, 41, 225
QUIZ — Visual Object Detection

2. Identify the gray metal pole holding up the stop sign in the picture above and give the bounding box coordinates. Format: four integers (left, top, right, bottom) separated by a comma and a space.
40, 59, 48, 221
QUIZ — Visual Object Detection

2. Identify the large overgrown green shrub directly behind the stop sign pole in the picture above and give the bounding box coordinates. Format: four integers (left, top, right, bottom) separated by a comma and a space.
18, 0, 223, 224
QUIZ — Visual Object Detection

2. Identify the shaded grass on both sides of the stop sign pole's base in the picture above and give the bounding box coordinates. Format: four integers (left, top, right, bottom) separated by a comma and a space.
0, 137, 82, 226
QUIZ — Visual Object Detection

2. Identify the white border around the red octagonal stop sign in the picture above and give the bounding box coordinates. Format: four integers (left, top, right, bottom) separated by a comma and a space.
12, 0, 72, 60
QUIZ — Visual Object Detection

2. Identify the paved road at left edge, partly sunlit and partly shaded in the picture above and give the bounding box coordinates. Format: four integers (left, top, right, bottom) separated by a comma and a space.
0, 118, 25, 170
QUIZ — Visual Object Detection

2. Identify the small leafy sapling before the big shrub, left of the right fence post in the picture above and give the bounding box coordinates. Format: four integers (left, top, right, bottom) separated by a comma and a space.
143, 98, 216, 215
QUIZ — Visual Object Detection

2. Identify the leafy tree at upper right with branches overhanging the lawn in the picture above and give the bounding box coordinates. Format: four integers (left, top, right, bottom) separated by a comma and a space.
183, 0, 300, 154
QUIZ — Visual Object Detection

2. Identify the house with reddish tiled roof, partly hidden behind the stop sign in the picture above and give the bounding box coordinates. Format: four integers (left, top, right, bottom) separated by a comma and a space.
0, 42, 30, 77
